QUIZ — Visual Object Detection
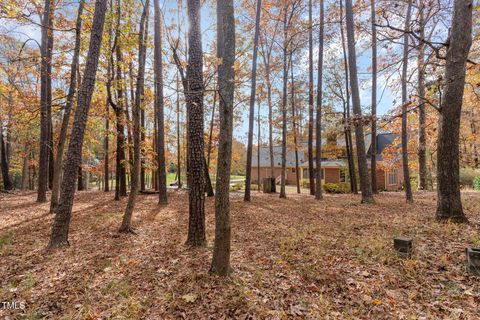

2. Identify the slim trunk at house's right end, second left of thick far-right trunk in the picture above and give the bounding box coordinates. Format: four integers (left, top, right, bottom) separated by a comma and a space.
402, 0, 413, 203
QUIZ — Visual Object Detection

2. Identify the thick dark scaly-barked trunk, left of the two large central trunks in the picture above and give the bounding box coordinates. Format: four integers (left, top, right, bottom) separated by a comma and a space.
186, 0, 206, 246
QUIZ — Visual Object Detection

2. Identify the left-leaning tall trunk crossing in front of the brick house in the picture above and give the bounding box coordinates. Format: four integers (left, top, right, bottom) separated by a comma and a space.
345, 0, 374, 203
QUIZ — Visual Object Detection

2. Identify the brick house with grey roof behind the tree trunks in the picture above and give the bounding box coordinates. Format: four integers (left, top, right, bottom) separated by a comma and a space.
251, 133, 403, 191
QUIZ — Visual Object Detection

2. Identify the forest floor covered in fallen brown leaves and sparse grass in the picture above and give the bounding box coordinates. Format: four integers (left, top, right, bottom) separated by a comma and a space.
0, 190, 480, 319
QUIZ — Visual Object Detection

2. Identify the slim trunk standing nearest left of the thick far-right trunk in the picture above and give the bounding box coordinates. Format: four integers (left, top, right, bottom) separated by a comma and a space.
417, 1, 428, 190
